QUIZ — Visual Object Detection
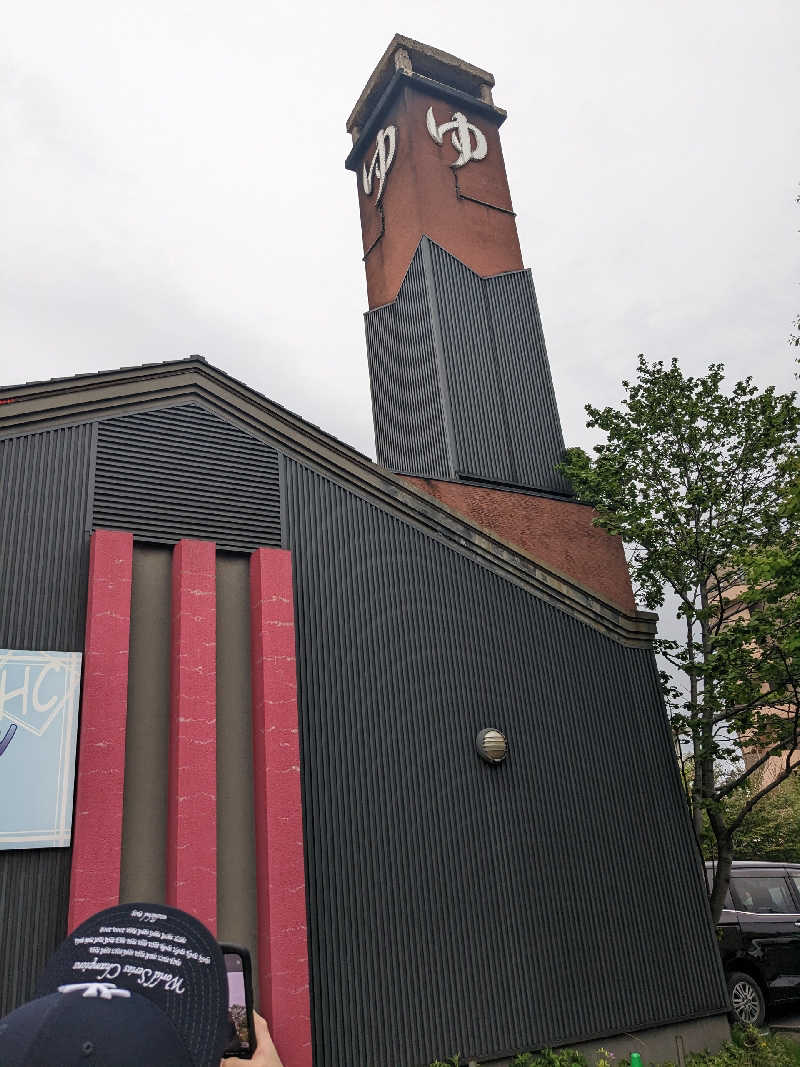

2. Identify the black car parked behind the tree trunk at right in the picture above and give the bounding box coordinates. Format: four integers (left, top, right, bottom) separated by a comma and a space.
706, 860, 800, 1026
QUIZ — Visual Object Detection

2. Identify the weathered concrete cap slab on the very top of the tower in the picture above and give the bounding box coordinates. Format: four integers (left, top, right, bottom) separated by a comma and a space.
347, 33, 495, 133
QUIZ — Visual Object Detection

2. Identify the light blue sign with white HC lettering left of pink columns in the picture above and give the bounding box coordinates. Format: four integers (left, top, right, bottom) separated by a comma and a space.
0, 649, 81, 849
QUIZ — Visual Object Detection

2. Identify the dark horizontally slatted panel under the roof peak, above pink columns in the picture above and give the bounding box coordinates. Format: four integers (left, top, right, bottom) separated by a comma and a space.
94, 403, 281, 551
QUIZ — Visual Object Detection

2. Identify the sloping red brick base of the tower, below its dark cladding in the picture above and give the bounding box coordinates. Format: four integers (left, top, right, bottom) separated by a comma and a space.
404, 477, 636, 615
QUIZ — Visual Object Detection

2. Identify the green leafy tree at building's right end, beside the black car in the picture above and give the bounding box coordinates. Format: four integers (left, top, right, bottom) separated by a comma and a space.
562, 356, 800, 920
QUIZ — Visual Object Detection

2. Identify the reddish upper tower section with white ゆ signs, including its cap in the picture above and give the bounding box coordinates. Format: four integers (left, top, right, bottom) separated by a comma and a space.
345, 34, 523, 308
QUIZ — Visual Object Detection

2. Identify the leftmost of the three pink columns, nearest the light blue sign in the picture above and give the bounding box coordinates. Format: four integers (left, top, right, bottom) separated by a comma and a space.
67, 530, 133, 930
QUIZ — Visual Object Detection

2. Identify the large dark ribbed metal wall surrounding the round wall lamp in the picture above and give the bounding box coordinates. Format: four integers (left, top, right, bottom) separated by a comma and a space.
286, 462, 726, 1067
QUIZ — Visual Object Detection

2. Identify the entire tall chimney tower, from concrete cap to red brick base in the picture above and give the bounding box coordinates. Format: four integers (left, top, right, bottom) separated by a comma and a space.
345, 34, 635, 611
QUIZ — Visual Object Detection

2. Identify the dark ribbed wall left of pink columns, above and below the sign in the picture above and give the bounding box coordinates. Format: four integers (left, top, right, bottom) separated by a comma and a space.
0, 425, 93, 1016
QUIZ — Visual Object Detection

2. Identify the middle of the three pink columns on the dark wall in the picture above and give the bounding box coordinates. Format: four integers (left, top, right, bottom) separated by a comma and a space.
166, 541, 217, 934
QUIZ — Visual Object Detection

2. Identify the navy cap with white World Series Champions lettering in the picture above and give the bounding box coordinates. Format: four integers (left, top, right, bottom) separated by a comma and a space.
0, 904, 228, 1067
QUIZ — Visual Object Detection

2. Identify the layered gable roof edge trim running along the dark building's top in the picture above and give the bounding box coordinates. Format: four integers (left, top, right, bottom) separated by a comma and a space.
0, 355, 656, 648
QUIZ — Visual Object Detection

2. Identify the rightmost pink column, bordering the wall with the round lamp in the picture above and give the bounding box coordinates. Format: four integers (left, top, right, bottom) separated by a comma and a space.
250, 548, 311, 1067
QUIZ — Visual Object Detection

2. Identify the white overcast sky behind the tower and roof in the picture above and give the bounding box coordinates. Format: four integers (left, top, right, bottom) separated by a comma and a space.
0, 0, 800, 463
